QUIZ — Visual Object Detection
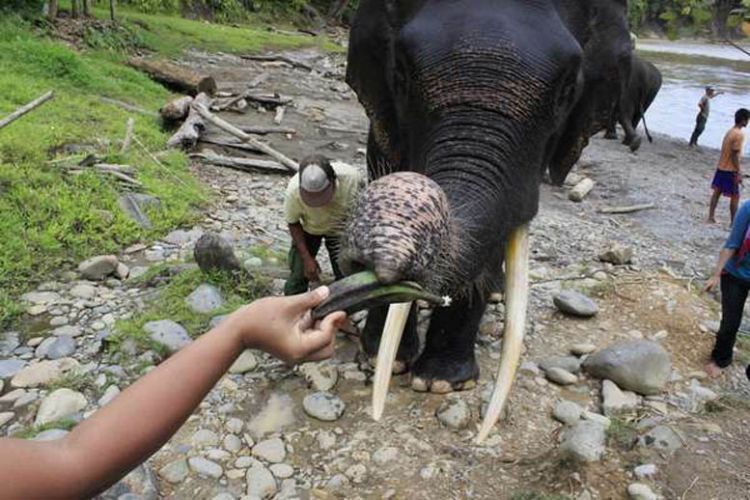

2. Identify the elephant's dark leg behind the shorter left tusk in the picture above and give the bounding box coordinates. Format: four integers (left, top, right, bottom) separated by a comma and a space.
361, 304, 419, 375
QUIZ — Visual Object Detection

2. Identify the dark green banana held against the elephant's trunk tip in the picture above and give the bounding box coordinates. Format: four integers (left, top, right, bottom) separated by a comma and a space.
312, 271, 449, 320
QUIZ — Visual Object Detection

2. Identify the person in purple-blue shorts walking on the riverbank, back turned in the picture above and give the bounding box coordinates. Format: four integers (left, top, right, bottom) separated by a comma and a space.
708, 108, 750, 223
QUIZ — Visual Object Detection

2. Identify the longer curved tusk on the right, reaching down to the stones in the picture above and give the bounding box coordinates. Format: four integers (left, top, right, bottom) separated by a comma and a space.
476, 224, 529, 444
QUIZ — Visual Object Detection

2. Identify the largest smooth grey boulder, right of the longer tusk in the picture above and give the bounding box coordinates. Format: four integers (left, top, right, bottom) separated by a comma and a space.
583, 340, 672, 395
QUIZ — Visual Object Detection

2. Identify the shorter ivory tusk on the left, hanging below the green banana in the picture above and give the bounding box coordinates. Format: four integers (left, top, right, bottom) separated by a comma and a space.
372, 302, 412, 420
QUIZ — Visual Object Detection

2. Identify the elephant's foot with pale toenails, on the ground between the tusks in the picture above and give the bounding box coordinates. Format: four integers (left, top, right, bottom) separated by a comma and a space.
411, 355, 479, 394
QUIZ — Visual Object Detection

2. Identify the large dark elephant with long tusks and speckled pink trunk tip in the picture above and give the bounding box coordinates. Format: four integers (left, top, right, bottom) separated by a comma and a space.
340, 0, 632, 438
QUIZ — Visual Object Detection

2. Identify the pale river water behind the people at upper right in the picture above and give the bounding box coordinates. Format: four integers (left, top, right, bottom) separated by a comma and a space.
638, 40, 750, 150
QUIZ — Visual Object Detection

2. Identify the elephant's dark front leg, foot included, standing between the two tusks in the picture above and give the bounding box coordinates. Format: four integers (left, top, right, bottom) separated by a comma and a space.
411, 289, 487, 393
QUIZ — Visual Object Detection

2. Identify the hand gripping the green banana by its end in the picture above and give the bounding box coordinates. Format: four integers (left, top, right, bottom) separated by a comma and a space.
228, 286, 346, 364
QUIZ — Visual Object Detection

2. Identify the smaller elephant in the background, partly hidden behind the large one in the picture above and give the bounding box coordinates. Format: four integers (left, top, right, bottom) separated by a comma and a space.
604, 53, 662, 151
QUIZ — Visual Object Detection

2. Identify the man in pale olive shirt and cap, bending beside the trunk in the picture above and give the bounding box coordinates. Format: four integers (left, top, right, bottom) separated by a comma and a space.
284, 155, 364, 295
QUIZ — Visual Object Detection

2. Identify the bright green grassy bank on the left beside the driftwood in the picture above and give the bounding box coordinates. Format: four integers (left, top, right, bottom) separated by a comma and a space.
0, 12, 336, 326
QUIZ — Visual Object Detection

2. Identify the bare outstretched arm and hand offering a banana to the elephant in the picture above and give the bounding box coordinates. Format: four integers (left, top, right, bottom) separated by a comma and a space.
0, 287, 345, 499
